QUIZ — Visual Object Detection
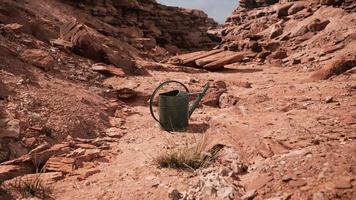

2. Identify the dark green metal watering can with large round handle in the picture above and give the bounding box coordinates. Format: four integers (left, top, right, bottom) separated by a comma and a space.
150, 80, 209, 131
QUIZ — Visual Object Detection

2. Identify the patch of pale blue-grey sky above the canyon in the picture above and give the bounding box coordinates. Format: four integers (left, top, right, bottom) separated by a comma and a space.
157, 0, 238, 24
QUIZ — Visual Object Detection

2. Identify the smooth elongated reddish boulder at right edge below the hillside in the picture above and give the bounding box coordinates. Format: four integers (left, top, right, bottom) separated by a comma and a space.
311, 55, 356, 80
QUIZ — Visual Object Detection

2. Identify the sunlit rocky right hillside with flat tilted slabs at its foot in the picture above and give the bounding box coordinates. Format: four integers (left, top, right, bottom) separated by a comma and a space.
169, 0, 356, 72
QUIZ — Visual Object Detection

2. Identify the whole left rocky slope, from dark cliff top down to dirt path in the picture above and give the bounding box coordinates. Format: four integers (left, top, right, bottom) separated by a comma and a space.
0, 0, 217, 188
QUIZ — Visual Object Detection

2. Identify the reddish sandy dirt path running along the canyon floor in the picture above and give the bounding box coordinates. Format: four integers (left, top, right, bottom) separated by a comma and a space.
51, 65, 356, 199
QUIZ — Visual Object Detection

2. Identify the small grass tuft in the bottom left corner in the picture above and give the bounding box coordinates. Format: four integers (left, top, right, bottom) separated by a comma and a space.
4, 173, 52, 199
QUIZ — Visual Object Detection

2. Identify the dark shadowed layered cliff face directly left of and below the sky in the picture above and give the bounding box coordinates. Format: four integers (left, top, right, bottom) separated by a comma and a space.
59, 0, 217, 50
